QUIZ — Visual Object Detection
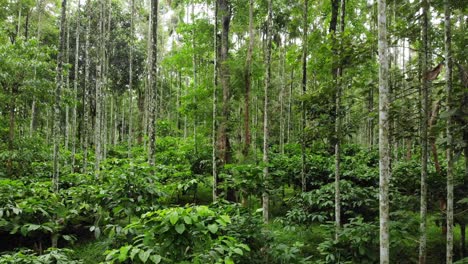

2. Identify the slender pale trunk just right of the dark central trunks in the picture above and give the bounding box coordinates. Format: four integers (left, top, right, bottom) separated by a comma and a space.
262, 0, 272, 223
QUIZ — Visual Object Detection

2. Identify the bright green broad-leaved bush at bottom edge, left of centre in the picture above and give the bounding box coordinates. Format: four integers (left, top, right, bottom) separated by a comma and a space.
102, 206, 250, 263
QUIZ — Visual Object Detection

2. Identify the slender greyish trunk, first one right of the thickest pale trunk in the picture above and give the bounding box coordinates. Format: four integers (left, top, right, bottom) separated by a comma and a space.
419, 0, 429, 264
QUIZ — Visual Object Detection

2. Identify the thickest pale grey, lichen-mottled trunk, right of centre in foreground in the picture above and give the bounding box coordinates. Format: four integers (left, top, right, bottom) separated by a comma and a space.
378, 0, 390, 264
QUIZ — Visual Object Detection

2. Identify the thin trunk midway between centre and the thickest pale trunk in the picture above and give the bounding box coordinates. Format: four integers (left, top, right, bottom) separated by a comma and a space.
301, 0, 309, 192
